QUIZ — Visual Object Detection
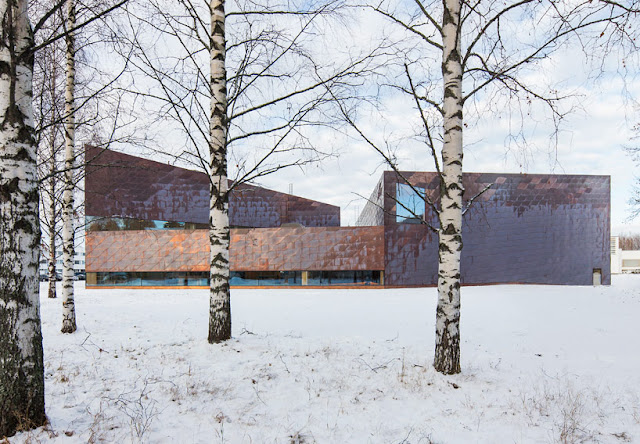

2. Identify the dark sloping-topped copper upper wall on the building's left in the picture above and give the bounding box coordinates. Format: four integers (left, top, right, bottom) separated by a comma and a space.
85, 148, 340, 227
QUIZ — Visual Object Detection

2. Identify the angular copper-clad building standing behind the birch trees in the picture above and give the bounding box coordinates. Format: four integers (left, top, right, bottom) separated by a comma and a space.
85, 149, 611, 287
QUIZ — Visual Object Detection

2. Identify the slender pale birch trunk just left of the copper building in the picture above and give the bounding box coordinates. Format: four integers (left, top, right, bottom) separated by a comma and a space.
62, 0, 76, 333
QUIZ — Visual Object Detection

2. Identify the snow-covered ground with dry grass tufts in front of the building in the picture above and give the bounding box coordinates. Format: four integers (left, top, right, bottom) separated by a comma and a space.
10, 275, 640, 443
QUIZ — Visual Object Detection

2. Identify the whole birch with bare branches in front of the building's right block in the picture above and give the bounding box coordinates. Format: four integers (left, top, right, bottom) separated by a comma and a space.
342, 0, 638, 374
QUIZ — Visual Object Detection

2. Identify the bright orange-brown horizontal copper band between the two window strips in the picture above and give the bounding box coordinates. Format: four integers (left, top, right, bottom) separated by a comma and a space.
85, 227, 384, 272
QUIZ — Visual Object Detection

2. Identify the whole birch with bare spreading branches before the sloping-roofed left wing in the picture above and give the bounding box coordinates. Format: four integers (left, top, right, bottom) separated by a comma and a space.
115, 0, 384, 343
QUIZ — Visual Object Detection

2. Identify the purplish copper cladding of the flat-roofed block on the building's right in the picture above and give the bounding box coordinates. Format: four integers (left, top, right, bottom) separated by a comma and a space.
383, 172, 611, 286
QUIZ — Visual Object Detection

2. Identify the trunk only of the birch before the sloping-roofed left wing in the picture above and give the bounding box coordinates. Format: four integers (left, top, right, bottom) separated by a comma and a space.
208, 0, 231, 343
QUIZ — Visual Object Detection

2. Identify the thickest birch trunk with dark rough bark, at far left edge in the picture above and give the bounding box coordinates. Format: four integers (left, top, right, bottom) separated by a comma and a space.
0, 0, 46, 436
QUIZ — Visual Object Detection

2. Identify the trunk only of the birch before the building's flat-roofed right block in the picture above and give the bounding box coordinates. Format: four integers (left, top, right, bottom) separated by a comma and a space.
433, 0, 464, 374
